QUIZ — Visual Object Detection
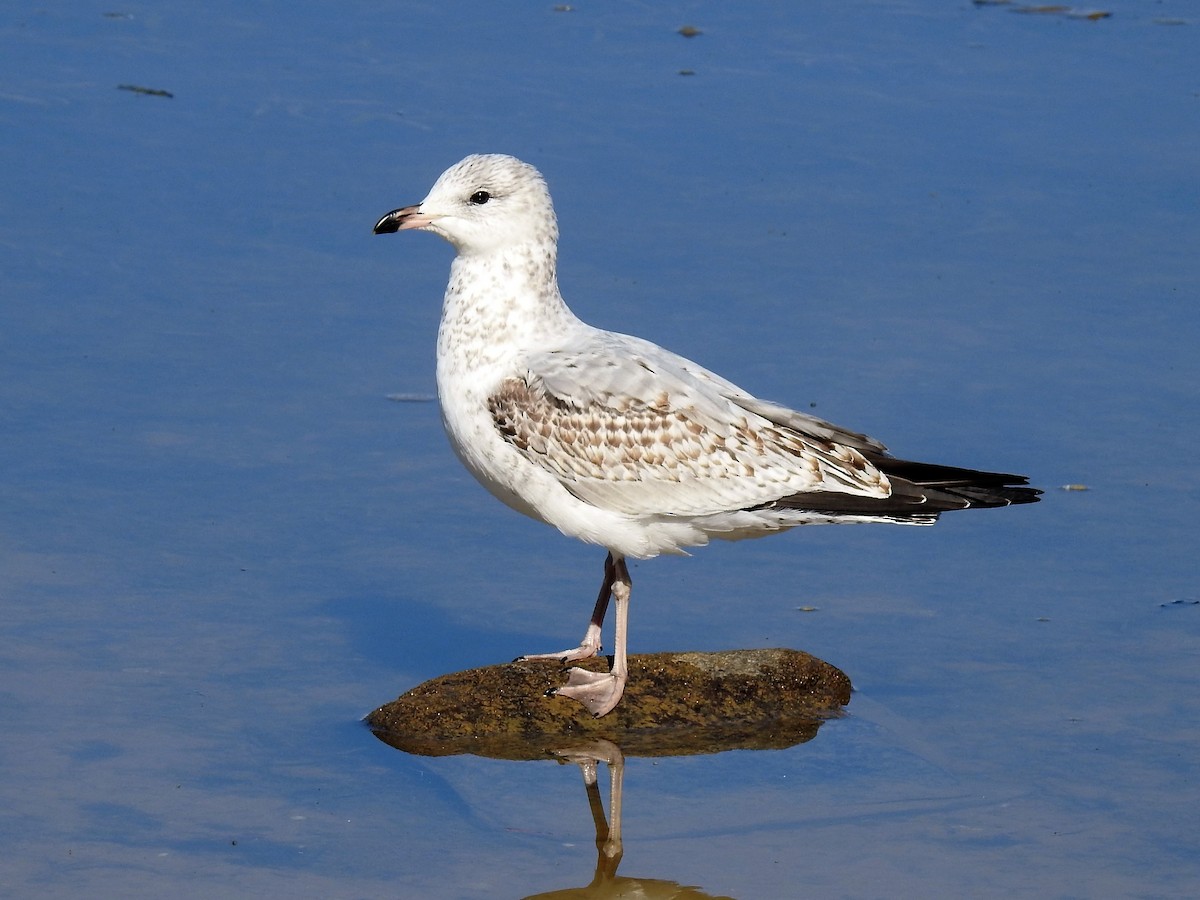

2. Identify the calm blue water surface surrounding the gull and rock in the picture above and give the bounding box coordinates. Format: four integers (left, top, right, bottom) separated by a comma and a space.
0, 1, 1200, 898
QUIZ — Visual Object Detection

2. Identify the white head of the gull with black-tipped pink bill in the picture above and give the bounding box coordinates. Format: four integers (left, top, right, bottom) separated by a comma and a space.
374, 154, 558, 256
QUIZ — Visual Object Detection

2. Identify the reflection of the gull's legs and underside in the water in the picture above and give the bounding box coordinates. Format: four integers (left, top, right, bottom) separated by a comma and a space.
526, 738, 732, 900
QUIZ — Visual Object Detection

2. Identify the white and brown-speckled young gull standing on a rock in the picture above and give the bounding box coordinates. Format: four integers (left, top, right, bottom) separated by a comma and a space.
374, 154, 1040, 716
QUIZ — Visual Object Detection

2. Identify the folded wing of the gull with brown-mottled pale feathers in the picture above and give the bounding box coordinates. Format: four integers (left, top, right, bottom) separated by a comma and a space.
488, 330, 892, 516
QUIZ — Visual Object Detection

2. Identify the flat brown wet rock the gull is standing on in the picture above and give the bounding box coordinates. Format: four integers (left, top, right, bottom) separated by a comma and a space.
367, 649, 851, 760
